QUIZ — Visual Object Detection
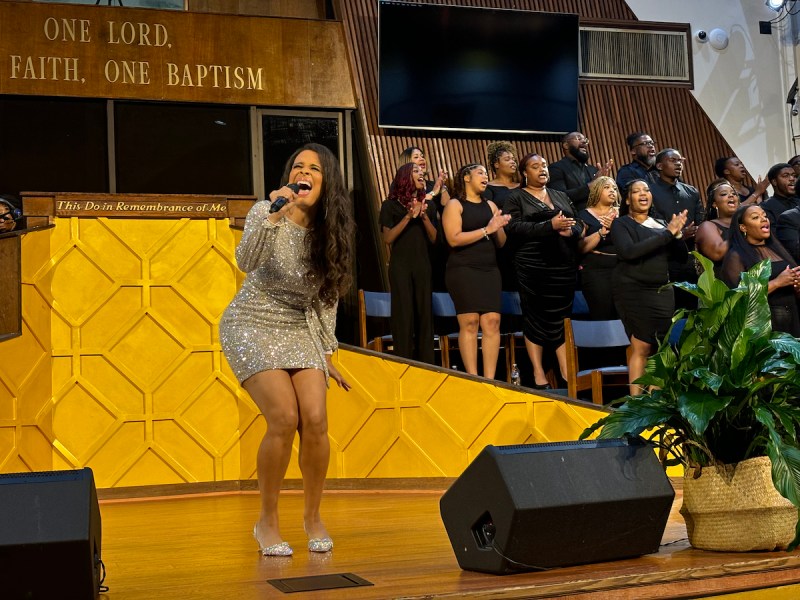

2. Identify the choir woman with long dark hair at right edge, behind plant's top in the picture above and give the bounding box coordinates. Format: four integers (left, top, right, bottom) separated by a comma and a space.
721, 205, 800, 337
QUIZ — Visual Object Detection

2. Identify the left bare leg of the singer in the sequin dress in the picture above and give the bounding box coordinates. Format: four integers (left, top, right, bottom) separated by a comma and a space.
242, 370, 298, 547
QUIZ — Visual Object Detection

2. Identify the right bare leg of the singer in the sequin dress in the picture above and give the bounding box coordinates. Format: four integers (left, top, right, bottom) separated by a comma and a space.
292, 369, 331, 538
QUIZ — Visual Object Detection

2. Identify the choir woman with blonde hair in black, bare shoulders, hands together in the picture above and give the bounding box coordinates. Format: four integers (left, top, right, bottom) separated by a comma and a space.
578, 176, 619, 321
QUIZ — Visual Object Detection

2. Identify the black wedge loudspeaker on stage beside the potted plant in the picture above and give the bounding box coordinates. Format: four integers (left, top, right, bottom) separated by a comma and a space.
439, 440, 675, 575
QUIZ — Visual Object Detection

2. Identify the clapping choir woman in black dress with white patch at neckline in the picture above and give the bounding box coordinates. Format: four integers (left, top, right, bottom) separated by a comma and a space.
611, 179, 687, 395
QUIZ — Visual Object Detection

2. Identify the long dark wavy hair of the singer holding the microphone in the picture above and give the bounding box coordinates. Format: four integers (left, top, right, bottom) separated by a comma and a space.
281, 143, 355, 306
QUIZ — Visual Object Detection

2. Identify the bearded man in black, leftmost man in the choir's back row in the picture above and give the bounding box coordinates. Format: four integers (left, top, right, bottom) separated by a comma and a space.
547, 131, 614, 210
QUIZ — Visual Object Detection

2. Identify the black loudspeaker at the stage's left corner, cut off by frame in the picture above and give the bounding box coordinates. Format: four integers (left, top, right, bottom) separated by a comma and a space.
0, 468, 101, 600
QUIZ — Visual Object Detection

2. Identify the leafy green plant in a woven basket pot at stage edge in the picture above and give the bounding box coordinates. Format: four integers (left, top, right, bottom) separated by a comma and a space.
581, 253, 800, 551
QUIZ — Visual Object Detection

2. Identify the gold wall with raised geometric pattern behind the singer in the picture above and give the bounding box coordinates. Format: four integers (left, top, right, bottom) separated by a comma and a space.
0, 218, 603, 487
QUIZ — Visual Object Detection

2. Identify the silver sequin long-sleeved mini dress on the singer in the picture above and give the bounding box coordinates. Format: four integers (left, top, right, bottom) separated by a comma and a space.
219, 200, 337, 383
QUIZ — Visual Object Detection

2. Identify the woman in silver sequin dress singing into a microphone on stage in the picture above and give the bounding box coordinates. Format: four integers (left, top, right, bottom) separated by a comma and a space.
220, 144, 355, 556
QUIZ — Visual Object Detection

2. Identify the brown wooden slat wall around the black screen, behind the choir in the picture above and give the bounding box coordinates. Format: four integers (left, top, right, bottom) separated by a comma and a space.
337, 0, 733, 205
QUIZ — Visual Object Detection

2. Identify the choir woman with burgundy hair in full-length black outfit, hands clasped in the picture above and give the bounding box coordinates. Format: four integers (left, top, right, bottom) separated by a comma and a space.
380, 163, 438, 364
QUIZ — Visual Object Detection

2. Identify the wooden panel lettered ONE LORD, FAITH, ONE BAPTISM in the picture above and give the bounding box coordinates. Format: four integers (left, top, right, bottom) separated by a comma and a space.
0, 2, 355, 108
